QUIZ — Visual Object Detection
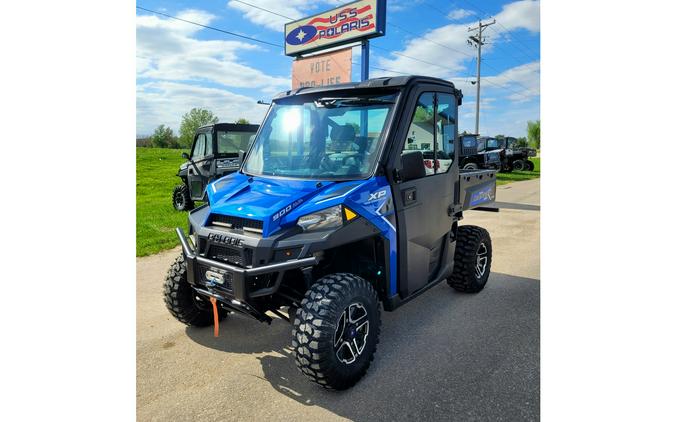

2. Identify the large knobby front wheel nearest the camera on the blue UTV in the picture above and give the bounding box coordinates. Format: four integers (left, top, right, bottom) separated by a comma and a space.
291, 273, 380, 390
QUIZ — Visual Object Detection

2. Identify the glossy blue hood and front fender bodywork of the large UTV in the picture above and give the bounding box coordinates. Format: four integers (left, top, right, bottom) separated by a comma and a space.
206, 172, 398, 296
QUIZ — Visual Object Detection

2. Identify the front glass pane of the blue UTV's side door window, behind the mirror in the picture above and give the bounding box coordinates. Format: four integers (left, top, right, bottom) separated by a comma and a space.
403, 92, 434, 176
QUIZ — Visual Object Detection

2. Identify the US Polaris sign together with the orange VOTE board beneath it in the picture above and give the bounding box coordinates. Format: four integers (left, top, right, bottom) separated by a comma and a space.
284, 0, 387, 89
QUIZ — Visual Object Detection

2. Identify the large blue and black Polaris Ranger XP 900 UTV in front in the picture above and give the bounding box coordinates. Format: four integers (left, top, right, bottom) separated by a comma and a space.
164, 76, 496, 389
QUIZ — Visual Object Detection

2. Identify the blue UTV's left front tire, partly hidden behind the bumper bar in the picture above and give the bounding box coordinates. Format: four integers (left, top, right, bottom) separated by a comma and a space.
164, 254, 227, 327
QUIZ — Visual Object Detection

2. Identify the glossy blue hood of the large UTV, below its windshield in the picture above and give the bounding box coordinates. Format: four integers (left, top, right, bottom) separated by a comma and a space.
206, 172, 363, 237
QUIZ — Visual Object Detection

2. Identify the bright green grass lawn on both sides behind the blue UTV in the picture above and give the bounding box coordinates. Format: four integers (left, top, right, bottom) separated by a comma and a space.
136, 148, 540, 256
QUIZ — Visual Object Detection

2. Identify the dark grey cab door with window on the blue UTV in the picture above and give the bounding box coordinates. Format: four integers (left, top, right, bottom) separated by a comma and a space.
392, 86, 461, 299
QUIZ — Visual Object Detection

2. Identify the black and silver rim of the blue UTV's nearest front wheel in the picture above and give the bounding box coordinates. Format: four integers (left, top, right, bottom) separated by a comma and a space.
333, 302, 370, 365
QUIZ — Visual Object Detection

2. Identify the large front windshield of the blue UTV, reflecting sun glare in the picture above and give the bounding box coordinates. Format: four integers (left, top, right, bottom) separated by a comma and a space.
242, 94, 396, 179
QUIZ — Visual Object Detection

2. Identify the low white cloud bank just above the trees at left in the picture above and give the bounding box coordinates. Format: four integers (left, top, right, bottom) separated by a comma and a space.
136, 82, 267, 135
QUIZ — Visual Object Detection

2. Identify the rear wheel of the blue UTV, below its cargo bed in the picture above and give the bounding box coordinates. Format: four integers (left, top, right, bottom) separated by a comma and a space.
448, 226, 492, 293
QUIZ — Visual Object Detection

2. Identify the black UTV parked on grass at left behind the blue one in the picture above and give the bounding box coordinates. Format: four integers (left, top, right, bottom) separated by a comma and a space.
173, 123, 259, 211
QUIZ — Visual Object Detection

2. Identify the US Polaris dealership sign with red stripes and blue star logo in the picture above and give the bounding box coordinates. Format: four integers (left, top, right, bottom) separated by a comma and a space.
284, 0, 386, 56
